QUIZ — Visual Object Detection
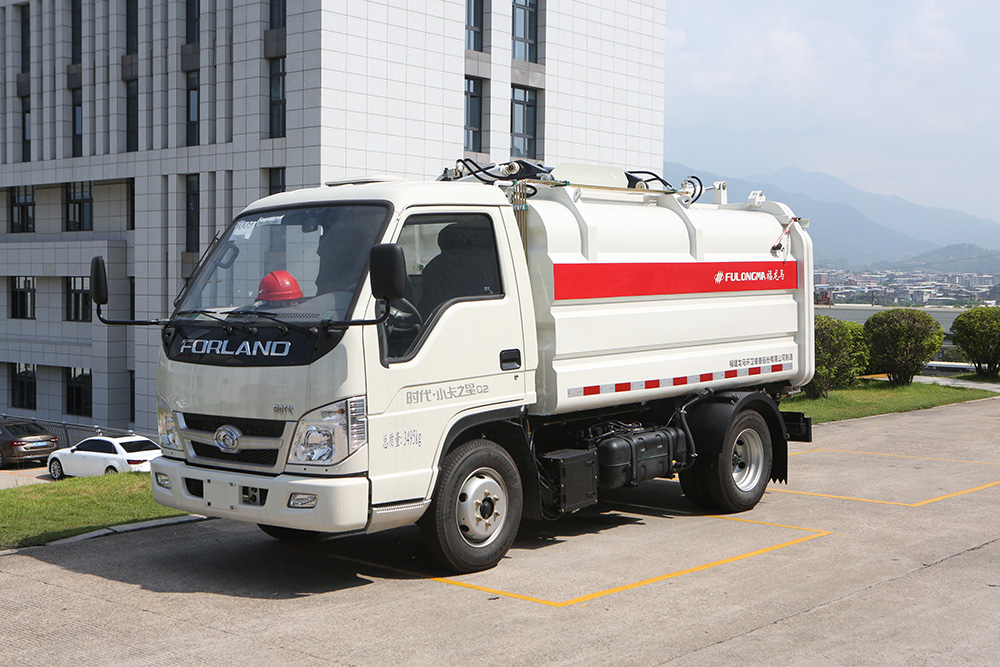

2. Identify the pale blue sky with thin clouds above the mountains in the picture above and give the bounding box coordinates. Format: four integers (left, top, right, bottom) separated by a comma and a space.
664, 0, 1000, 221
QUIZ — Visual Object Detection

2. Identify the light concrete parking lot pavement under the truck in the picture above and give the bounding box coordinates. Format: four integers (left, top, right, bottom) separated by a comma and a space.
0, 398, 1000, 665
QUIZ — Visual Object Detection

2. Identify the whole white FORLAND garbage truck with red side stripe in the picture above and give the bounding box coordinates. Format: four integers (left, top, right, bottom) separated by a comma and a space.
92, 160, 814, 572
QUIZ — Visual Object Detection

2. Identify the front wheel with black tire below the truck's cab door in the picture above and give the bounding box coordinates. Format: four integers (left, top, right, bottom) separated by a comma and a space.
420, 439, 523, 572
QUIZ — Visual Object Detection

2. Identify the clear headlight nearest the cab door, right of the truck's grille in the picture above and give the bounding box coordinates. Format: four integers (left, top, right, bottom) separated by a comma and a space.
288, 396, 368, 466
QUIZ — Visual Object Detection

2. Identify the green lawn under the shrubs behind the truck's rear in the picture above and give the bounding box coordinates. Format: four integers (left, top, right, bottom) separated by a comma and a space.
781, 380, 996, 424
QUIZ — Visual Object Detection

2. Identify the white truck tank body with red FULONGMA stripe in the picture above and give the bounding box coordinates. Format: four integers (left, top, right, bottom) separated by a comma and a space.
526, 178, 814, 414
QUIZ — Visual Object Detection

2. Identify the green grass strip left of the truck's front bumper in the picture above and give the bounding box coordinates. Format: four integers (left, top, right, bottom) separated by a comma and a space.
0, 473, 186, 549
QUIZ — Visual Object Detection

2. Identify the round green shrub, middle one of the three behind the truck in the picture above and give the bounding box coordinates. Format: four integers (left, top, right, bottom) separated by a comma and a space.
865, 308, 944, 385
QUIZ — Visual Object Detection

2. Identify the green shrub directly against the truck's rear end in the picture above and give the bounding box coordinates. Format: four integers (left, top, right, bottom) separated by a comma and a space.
803, 315, 868, 398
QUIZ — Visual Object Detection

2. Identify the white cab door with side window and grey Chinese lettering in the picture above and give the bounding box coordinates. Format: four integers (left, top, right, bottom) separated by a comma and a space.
364, 207, 526, 505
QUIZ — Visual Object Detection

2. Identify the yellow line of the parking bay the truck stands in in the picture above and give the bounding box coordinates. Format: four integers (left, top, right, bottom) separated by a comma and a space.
288, 516, 833, 608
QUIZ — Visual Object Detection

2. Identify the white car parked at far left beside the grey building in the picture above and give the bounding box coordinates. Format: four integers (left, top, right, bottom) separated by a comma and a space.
48, 435, 161, 479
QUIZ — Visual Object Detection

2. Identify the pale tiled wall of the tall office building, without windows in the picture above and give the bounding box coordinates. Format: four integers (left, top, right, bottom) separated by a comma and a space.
0, 0, 666, 430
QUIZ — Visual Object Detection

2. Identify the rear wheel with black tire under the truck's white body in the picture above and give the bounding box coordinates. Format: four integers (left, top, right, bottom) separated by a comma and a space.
698, 410, 771, 512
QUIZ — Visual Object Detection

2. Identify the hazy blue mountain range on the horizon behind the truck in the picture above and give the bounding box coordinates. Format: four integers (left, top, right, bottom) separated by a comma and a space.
663, 162, 1000, 273
